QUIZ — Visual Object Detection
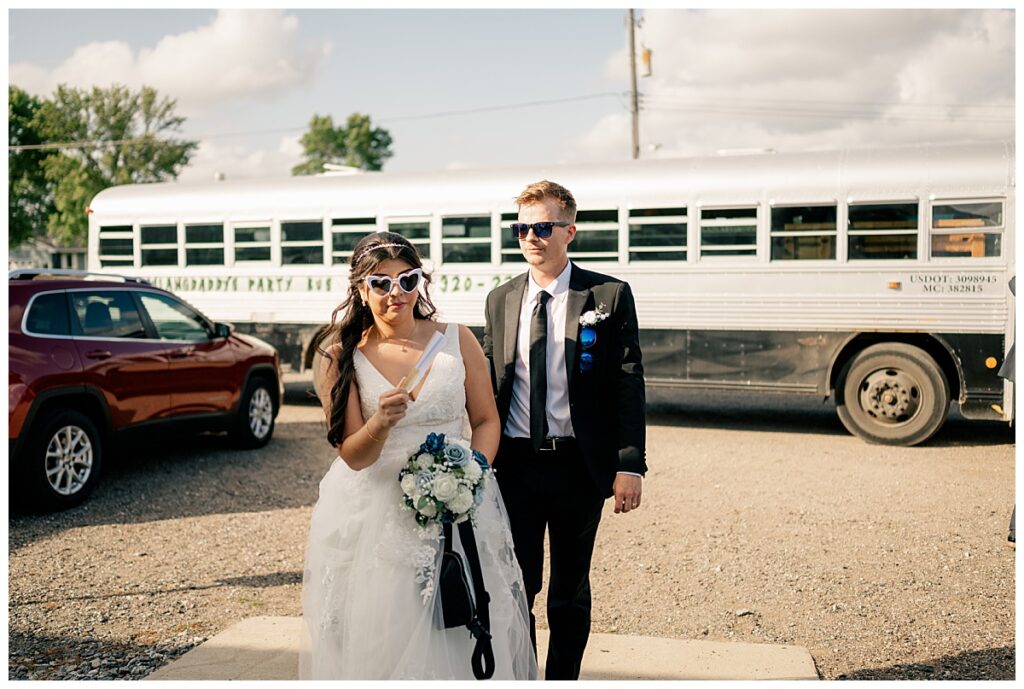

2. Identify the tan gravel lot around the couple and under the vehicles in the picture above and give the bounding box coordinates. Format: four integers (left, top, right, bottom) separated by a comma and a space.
8, 388, 1016, 680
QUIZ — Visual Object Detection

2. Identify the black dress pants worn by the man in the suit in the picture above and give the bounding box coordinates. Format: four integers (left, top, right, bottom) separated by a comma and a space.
495, 437, 604, 680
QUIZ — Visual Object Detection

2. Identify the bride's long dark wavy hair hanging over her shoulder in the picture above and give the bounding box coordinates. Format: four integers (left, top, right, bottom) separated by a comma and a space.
313, 232, 437, 447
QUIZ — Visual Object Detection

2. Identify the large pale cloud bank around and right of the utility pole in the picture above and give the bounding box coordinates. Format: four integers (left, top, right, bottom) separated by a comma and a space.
573, 9, 1015, 159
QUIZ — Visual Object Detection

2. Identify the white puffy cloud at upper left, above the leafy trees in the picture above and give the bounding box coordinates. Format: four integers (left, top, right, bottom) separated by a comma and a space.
9, 9, 331, 116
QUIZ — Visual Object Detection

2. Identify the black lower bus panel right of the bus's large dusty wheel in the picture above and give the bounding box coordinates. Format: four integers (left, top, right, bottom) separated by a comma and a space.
937, 333, 1006, 421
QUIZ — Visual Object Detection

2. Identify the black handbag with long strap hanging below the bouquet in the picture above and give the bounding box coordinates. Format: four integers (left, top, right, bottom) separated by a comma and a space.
437, 521, 495, 680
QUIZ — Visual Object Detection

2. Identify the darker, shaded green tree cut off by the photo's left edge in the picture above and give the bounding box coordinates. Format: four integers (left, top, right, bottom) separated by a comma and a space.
7, 86, 54, 248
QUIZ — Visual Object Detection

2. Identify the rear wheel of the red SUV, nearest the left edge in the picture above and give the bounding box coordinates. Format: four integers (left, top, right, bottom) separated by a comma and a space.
22, 410, 103, 510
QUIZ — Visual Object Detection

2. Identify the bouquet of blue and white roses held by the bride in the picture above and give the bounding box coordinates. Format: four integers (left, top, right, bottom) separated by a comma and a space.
398, 433, 490, 526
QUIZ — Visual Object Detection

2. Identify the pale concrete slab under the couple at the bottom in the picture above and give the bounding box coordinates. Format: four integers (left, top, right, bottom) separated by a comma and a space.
145, 617, 818, 680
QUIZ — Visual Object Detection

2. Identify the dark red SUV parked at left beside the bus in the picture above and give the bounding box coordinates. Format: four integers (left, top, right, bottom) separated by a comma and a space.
7, 270, 284, 509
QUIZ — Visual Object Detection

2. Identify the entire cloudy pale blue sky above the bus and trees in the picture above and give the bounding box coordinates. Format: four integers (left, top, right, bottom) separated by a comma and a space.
8, 9, 1015, 179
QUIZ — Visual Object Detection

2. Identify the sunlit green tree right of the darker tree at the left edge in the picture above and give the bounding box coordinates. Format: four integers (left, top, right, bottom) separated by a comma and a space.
36, 85, 199, 243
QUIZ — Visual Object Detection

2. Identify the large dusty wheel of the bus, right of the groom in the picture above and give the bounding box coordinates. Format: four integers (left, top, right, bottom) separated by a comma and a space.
836, 342, 949, 446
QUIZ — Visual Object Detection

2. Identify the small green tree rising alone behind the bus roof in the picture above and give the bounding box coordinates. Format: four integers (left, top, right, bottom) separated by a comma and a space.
292, 113, 394, 175
